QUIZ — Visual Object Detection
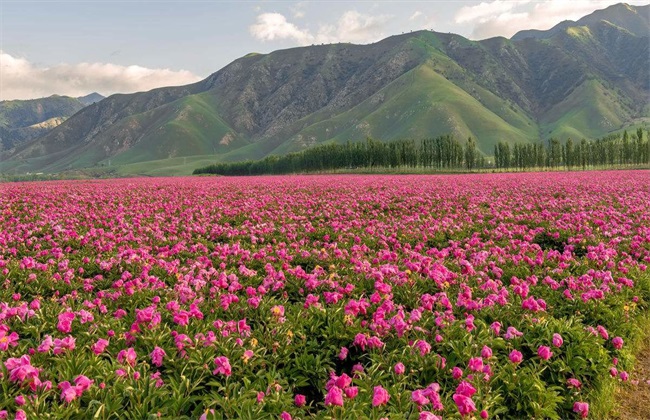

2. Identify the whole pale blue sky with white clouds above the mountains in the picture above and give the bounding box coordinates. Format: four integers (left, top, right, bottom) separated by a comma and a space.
0, 0, 648, 100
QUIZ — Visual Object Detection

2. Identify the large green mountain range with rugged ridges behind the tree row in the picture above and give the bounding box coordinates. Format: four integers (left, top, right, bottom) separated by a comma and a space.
0, 4, 650, 174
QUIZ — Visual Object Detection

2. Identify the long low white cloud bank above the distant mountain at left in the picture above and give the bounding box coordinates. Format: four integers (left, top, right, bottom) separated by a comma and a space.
0, 50, 200, 100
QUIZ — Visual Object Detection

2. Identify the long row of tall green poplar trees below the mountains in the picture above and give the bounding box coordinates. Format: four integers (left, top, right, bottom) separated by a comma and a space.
194, 128, 650, 175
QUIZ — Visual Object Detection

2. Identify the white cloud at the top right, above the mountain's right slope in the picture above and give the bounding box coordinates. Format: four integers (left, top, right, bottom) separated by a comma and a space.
455, 0, 647, 39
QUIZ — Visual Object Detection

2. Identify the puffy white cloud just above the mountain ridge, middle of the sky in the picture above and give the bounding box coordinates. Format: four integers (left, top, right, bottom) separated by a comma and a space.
249, 10, 390, 45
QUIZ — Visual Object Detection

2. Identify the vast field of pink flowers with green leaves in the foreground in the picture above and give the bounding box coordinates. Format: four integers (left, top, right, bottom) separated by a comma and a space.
0, 171, 650, 420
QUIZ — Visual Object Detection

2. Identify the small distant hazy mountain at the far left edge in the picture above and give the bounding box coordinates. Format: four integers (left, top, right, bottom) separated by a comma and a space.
0, 93, 104, 153
